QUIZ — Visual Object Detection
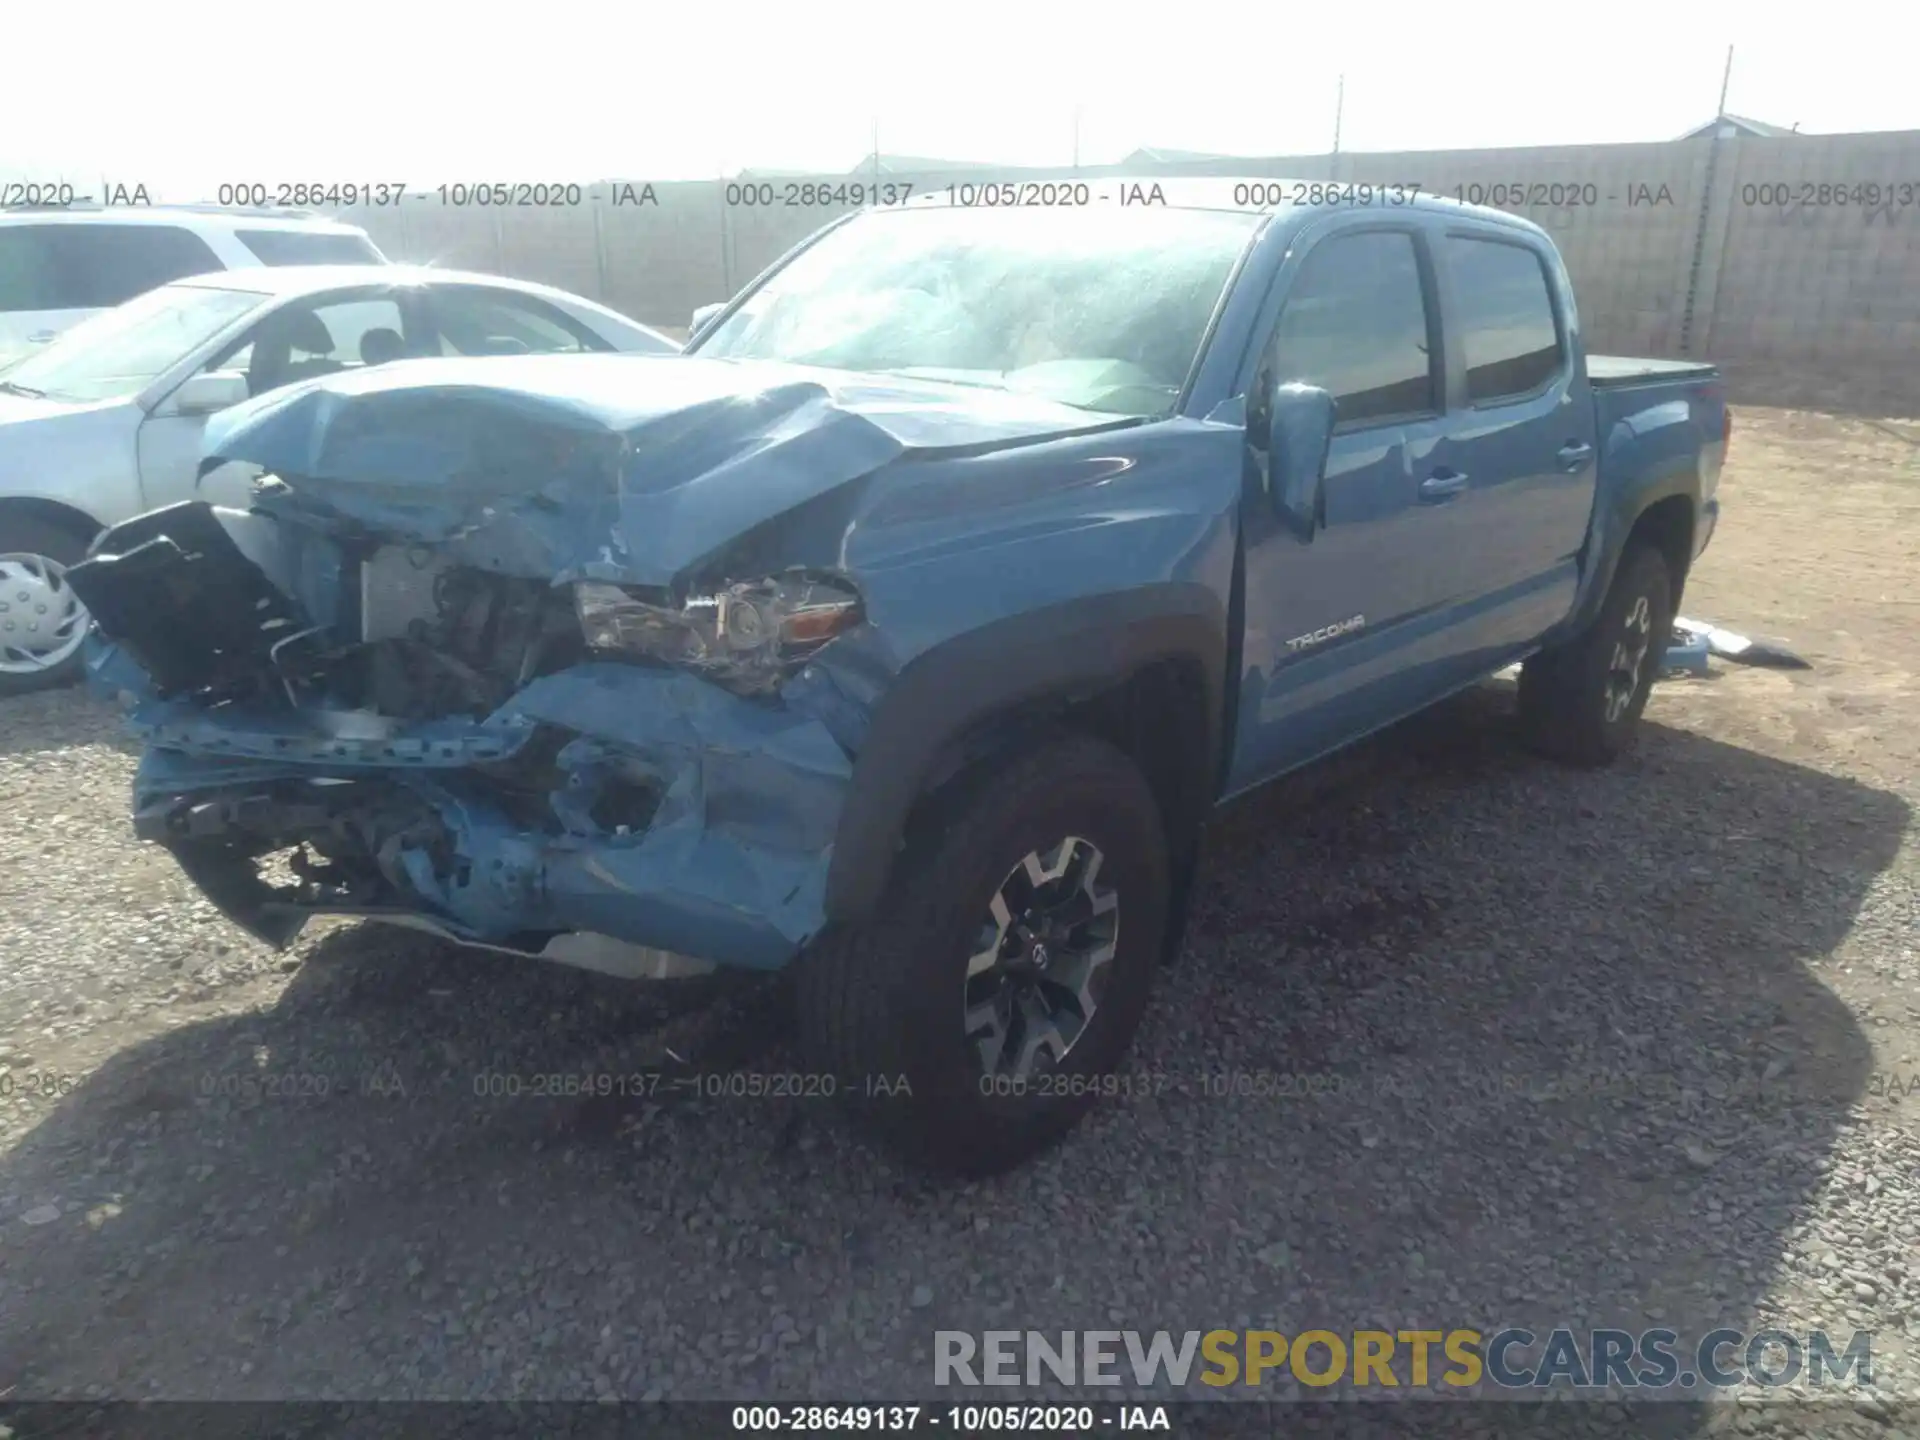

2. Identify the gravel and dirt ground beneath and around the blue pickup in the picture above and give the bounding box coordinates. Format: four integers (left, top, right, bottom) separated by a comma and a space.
0, 376, 1920, 1434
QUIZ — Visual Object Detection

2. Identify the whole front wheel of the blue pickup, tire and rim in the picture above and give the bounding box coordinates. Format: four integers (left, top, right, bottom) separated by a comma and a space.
799, 737, 1169, 1175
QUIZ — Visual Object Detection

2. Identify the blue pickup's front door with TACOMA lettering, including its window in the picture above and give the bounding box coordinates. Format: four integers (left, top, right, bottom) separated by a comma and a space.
1229, 215, 1442, 789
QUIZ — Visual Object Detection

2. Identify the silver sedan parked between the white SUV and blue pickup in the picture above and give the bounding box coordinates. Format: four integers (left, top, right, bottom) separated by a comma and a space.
0, 265, 680, 695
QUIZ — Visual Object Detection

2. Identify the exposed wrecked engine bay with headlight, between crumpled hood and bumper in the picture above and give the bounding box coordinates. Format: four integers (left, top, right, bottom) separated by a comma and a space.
75, 501, 858, 720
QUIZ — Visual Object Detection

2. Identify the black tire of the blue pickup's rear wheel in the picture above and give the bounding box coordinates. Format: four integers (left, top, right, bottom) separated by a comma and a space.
1521, 541, 1674, 768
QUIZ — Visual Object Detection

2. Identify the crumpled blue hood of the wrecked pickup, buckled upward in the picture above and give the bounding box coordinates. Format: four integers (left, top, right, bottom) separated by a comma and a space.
202, 355, 1131, 586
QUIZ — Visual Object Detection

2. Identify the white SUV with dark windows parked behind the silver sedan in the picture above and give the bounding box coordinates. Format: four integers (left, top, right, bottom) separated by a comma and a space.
0, 205, 386, 367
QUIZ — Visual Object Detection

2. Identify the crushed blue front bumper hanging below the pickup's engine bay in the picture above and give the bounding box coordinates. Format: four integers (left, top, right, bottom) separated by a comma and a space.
110, 664, 851, 968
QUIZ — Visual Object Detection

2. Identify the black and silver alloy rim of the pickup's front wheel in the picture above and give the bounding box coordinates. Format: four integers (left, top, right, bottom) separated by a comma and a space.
966, 835, 1119, 1081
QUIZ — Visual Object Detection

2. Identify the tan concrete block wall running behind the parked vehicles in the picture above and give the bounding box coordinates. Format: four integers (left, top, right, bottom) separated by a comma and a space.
334, 131, 1920, 372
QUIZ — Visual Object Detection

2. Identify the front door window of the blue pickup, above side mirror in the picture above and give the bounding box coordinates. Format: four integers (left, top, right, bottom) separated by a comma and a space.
1273, 230, 1436, 426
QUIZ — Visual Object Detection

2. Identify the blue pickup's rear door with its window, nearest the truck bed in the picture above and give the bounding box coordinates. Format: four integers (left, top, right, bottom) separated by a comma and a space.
1419, 229, 1597, 652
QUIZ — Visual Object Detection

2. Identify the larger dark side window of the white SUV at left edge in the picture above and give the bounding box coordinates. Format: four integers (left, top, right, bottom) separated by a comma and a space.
0, 225, 227, 311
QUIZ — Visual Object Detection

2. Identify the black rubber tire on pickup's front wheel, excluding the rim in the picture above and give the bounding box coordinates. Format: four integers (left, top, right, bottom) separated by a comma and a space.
797, 735, 1171, 1175
